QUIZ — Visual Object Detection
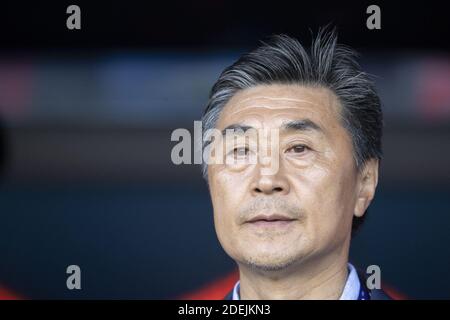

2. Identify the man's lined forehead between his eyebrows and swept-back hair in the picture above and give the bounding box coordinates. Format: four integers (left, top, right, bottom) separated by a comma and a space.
217, 84, 341, 131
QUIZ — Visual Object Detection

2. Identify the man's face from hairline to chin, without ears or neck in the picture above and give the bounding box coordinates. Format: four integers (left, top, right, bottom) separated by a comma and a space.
208, 85, 370, 270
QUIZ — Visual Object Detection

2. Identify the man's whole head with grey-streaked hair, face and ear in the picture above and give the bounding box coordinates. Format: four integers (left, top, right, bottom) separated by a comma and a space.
202, 28, 382, 270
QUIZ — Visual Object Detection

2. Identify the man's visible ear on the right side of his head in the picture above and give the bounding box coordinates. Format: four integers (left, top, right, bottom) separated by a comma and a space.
354, 159, 379, 217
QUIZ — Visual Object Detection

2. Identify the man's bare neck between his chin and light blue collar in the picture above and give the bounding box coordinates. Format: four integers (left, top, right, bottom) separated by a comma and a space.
239, 242, 348, 300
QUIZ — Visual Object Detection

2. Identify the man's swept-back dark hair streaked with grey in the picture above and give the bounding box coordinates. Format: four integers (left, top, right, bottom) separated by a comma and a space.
202, 28, 383, 229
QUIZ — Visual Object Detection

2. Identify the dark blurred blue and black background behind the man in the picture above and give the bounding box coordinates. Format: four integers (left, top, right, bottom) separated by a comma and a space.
0, 0, 450, 299
